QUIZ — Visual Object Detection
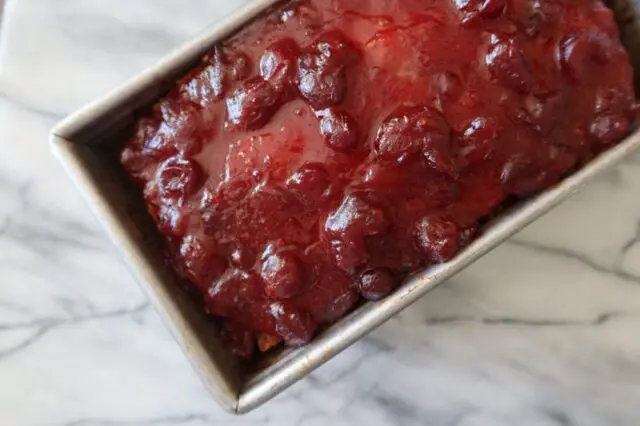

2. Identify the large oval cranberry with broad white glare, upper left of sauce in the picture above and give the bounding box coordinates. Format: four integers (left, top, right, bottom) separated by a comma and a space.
227, 77, 282, 130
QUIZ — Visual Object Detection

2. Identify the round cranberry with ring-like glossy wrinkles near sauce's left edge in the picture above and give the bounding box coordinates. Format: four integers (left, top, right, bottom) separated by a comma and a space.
156, 157, 202, 206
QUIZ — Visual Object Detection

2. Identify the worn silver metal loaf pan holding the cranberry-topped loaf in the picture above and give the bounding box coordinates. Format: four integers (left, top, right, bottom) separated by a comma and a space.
51, 0, 640, 414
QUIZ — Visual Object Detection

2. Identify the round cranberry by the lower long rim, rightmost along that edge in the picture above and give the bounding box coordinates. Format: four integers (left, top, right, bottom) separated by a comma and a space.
417, 214, 461, 263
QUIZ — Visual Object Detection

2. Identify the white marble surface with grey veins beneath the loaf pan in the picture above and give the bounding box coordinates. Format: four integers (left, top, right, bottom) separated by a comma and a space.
0, 0, 640, 426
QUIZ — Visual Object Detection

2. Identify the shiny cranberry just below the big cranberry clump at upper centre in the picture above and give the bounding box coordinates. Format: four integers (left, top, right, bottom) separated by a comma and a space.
318, 108, 359, 152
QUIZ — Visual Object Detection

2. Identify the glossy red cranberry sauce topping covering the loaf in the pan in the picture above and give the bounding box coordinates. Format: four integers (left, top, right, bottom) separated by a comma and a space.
122, 0, 635, 358
